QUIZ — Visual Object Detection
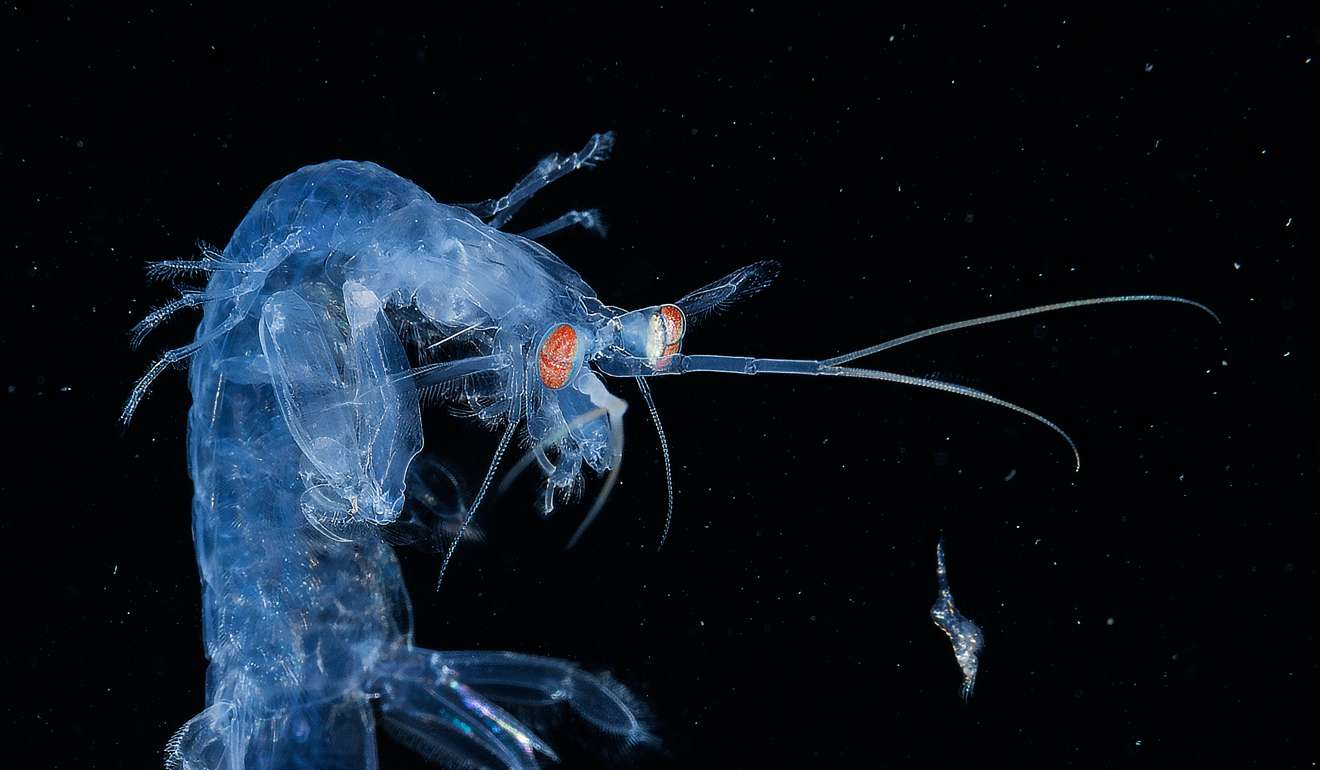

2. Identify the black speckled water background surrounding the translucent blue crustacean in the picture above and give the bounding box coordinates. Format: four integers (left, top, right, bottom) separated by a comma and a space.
0, 3, 1320, 769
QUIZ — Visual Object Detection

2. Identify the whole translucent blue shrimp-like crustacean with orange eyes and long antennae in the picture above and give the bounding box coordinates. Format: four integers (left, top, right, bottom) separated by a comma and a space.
131, 133, 1208, 770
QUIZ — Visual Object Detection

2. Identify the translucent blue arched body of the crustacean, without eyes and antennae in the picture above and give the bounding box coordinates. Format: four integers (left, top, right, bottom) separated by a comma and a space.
157, 161, 649, 770
